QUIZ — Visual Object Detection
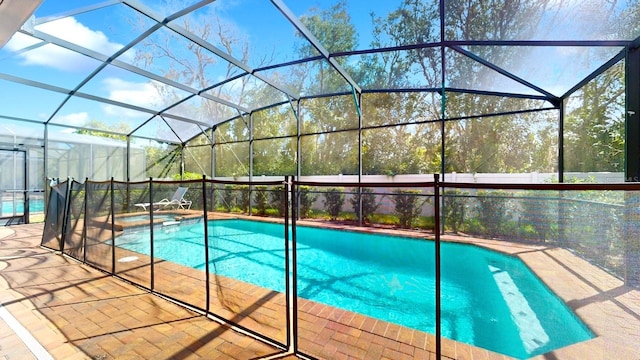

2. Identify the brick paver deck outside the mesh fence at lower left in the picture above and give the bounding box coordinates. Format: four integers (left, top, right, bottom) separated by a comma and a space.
0, 224, 295, 360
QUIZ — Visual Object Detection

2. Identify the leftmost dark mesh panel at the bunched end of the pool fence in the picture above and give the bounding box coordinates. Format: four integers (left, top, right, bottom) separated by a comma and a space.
40, 181, 69, 251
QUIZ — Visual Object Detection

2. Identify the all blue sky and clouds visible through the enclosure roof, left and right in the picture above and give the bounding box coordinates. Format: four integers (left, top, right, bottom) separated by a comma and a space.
0, 0, 632, 142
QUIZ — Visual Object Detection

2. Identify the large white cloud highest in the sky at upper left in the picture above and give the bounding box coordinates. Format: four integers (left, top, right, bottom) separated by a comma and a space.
6, 17, 131, 71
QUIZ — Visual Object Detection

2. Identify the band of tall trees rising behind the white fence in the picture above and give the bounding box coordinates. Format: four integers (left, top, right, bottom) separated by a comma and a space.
132, 0, 637, 180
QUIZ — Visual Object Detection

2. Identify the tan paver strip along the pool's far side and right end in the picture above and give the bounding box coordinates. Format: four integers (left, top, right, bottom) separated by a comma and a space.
210, 213, 640, 359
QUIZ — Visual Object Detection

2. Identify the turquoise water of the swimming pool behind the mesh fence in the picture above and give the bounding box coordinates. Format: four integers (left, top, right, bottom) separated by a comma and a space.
116, 220, 593, 358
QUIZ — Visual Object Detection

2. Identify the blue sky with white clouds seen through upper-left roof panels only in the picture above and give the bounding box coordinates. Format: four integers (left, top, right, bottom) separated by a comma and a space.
0, 0, 404, 141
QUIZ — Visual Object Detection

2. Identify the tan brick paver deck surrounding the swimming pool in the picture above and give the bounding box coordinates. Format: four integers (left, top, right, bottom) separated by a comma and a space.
0, 224, 640, 359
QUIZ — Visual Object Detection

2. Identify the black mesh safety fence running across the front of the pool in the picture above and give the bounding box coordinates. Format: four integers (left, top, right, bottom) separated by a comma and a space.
43, 176, 640, 358
